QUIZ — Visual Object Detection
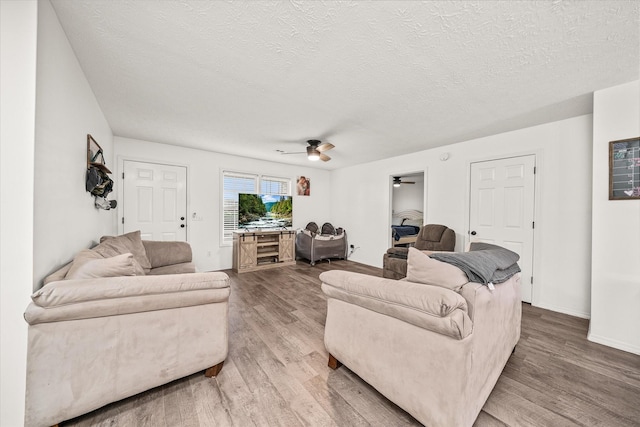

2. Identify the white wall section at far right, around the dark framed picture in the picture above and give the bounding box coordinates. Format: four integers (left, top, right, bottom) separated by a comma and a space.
589, 81, 640, 354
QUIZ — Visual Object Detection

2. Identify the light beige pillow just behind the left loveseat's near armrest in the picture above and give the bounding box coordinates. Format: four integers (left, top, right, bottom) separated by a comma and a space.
65, 249, 144, 280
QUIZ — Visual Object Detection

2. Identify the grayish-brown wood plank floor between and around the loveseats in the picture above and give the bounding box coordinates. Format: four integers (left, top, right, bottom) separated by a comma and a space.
63, 261, 640, 427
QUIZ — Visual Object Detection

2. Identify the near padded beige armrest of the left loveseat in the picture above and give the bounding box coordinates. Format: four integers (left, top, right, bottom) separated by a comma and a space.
25, 272, 230, 325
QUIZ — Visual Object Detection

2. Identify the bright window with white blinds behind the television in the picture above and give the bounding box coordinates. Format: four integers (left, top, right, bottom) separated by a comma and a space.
221, 171, 291, 245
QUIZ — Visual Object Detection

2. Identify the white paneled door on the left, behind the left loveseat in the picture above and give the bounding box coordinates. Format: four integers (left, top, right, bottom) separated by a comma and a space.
122, 160, 187, 241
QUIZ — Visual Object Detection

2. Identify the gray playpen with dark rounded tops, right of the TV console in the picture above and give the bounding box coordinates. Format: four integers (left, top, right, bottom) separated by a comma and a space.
296, 222, 349, 265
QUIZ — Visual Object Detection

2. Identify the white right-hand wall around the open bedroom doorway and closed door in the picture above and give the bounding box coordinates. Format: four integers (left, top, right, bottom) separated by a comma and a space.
332, 115, 592, 317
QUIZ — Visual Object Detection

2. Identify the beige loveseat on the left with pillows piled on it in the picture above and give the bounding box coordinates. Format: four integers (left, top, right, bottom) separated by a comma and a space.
25, 233, 230, 426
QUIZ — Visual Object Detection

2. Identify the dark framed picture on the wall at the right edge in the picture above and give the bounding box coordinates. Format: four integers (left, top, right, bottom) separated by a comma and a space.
609, 137, 640, 200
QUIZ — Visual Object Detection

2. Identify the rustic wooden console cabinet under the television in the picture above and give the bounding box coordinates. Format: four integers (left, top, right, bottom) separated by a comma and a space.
233, 230, 296, 273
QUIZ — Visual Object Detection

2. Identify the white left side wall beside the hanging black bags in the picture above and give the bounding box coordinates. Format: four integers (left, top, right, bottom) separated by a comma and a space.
33, 0, 116, 288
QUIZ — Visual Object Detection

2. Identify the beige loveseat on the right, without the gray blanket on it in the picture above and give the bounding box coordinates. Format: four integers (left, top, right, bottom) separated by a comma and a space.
320, 248, 522, 427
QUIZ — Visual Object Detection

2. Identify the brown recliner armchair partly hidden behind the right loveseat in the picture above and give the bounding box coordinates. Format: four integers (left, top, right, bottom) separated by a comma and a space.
382, 224, 456, 280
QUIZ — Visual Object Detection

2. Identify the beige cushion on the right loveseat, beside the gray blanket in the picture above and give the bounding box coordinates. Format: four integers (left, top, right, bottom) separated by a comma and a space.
407, 248, 469, 292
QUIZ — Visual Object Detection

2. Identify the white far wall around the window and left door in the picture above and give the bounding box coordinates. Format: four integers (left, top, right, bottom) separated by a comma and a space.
114, 137, 330, 271
